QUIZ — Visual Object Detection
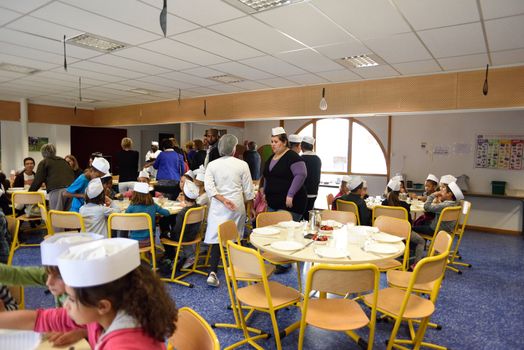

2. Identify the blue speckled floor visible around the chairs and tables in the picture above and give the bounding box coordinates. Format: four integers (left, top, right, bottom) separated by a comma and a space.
14, 232, 524, 350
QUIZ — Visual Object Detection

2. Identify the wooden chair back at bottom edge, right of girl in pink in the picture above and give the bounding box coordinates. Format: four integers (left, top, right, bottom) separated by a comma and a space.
167, 307, 220, 350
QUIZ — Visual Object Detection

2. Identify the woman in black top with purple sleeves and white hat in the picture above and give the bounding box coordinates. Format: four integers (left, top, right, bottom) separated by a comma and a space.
260, 127, 307, 221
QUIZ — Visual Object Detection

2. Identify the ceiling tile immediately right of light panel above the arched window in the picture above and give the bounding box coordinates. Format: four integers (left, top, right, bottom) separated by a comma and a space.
364, 33, 431, 64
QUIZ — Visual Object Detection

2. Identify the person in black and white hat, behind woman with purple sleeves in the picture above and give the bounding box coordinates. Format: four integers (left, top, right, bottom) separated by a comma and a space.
300, 136, 322, 215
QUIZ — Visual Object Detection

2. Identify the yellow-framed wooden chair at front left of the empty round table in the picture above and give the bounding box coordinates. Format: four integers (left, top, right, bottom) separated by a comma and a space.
227, 241, 302, 350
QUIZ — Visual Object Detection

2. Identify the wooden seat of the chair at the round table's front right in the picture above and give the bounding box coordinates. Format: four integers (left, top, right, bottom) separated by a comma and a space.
364, 288, 435, 319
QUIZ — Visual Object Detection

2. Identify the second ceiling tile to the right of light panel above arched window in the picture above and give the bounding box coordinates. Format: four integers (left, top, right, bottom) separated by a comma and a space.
418, 22, 486, 57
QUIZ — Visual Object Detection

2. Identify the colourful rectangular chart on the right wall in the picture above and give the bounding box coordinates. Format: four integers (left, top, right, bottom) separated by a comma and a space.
475, 135, 524, 170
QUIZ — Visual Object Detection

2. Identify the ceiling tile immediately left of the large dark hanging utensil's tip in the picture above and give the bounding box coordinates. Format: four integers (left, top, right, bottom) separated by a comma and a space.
31, 2, 160, 45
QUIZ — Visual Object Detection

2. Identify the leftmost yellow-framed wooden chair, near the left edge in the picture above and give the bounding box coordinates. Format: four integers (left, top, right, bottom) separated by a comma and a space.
7, 192, 46, 265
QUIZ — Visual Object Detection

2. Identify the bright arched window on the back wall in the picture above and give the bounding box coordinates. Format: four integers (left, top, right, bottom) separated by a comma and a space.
299, 118, 387, 176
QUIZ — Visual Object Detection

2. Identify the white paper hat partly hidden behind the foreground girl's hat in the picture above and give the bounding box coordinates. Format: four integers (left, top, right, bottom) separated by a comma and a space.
40, 232, 104, 266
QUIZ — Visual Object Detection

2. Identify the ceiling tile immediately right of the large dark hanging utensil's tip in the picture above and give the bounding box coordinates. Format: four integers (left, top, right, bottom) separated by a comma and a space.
172, 29, 262, 60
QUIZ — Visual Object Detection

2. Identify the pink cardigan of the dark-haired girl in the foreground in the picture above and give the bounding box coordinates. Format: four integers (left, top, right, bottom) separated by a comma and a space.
34, 308, 166, 350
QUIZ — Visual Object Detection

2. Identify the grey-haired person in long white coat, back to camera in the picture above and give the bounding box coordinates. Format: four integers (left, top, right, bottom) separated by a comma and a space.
204, 135, 255, 287
